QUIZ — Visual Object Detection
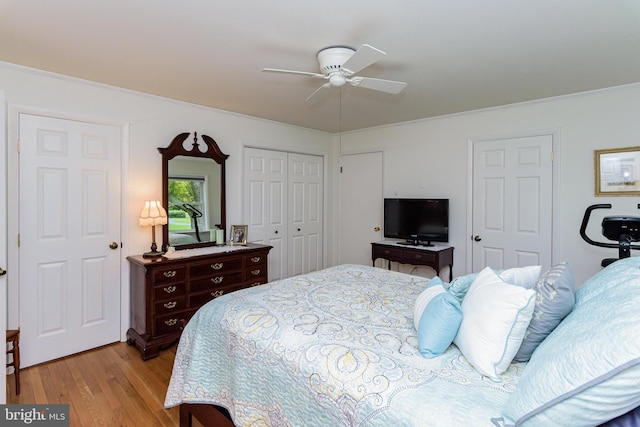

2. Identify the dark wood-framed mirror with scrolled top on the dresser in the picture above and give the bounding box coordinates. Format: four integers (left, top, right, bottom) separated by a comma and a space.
158, 132, 229, 250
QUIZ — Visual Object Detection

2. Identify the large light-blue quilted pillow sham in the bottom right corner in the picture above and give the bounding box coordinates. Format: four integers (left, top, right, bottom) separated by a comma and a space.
500, 257, 640, 427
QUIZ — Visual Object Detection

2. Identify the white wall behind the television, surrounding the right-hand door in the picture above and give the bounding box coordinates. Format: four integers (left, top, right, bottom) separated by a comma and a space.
342, 84, 640, 285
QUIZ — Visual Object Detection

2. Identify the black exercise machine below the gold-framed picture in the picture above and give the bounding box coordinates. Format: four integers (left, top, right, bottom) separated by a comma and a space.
580, 203, 640, 267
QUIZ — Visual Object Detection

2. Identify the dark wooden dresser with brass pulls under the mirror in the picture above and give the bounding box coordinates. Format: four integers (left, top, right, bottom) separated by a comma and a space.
127, 243, 271, 360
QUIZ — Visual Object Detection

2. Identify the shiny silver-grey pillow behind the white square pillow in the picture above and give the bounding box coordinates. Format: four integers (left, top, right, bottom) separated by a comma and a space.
513, 262, 575, 362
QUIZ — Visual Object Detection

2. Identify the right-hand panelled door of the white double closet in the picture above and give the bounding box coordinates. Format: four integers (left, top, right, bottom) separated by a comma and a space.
288, 153, 323, 276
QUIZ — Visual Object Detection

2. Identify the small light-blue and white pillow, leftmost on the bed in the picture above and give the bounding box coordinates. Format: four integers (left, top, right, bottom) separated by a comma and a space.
413, 276, 462, 359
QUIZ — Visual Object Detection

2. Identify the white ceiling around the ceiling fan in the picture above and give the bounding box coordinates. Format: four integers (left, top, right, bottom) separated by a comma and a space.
0, 0, 640, 132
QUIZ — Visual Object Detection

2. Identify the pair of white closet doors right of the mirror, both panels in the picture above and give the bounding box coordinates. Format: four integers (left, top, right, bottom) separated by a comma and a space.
244, 148, 324, 281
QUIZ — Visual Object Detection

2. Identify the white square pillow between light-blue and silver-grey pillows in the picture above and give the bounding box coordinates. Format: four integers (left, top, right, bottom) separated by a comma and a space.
453, 267, 536, 380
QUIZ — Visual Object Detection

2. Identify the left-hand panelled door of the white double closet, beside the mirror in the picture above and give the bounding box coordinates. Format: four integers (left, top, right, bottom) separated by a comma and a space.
244, 148, 288, 281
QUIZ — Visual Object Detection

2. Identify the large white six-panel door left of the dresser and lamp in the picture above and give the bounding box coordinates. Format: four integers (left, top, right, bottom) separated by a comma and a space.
19, 113, 121, 366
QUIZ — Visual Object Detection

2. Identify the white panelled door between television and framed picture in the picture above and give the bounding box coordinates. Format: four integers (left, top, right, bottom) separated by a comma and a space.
472, 135, 553, 272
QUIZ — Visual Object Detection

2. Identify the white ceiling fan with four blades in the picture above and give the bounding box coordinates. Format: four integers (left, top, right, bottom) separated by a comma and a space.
262, 44, 407, 101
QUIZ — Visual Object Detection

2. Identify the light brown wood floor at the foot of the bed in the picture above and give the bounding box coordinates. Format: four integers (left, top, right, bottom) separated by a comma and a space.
7, 343, 179, 427
